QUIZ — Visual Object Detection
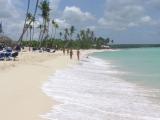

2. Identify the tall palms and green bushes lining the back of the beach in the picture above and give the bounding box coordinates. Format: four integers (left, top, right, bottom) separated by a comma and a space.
19, 0, 113, 49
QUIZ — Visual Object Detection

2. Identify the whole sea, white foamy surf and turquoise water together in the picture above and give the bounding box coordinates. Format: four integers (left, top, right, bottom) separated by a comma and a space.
42, 48, 160, 120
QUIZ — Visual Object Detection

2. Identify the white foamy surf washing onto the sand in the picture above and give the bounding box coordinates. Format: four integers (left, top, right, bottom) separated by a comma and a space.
42, 57, 160, 120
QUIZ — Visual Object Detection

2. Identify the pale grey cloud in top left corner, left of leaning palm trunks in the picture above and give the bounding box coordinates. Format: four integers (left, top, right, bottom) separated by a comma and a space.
0, 0, 24, 39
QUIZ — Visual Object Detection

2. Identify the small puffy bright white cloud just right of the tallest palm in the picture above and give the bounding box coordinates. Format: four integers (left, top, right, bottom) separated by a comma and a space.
63, 6, 94, 23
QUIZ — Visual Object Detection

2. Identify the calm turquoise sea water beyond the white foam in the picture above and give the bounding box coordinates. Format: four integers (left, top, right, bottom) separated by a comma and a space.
93, 48, 160, 89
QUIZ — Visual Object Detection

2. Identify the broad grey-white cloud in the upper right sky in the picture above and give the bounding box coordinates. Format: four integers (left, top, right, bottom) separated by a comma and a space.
98, 0, 154, 30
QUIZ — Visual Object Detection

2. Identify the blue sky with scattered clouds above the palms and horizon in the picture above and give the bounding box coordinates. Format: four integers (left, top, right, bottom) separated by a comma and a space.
0, 0, 160, 44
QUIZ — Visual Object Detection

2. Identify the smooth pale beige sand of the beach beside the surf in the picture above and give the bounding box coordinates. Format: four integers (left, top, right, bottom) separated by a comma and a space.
0, 50, 102, 120
